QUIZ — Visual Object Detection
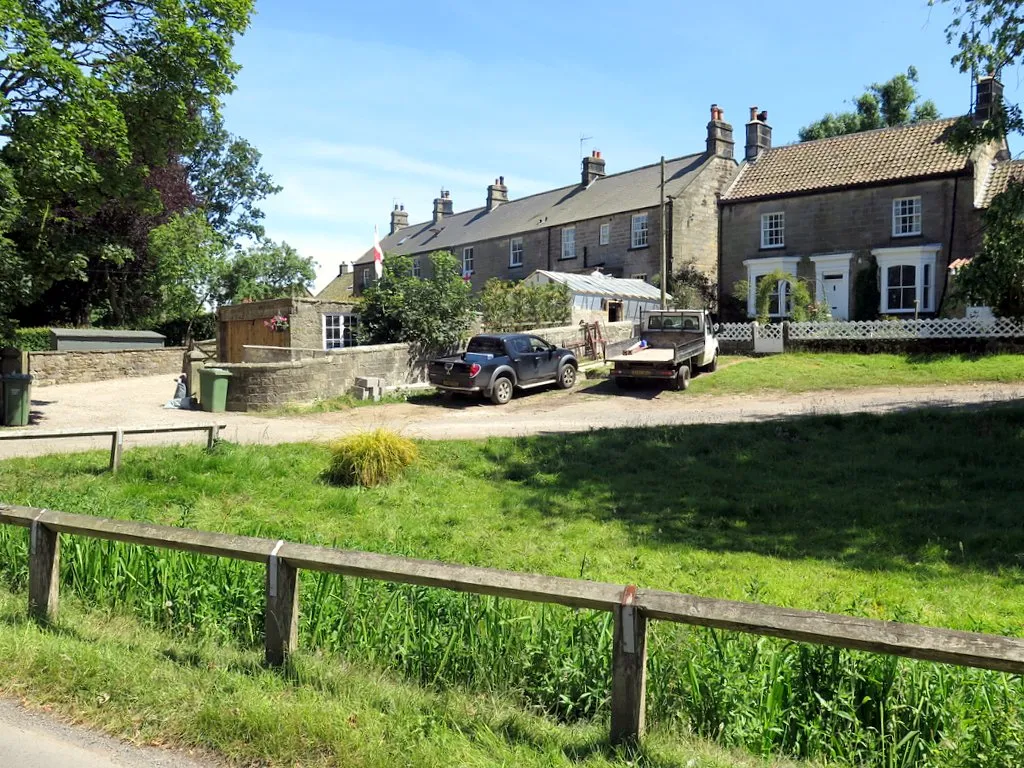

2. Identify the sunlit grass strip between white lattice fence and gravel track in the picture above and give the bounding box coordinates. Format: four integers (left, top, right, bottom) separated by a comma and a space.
690, 352, 1024, 394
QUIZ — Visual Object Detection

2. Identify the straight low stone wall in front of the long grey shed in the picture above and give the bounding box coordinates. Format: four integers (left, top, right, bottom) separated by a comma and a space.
29, 347, 185, 386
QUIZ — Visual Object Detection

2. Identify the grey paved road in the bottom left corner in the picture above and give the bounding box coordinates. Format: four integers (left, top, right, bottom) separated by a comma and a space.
0, 698, 216, 768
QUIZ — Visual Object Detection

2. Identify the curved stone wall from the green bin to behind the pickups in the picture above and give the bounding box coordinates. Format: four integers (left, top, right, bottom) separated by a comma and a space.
218, 322, 634, 411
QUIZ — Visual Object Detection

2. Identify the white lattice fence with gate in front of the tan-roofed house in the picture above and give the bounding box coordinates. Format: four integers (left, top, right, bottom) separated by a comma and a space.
718, 317, 1024, 353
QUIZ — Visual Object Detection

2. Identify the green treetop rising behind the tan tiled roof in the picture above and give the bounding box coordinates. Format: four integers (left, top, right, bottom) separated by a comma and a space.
800, 67, 939, 141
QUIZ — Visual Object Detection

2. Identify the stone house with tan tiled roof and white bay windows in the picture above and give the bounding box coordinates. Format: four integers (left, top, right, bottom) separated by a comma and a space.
719, 78, 1016, 319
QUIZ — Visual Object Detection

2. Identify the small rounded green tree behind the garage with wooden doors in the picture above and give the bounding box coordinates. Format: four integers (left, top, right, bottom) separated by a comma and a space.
220, 241, 316, 304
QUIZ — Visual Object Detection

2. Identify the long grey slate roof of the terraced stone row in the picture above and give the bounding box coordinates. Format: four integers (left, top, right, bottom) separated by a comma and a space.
355, 154, 710, 264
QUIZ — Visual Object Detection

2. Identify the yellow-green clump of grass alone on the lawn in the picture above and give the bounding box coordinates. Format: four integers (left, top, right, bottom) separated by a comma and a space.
327, 429, 417, 487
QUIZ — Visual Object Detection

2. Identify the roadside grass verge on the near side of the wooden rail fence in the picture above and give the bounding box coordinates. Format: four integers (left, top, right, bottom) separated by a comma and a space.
0, 588, 790, 768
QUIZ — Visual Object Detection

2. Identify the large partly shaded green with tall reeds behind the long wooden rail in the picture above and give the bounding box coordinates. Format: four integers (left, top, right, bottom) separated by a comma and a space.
0, 408, 1024, 768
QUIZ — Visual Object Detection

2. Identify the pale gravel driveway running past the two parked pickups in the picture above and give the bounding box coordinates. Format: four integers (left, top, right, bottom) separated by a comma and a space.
0, 376, 1024, 458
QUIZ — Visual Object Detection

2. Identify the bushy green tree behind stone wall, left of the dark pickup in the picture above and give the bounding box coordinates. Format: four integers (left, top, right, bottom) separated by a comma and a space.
359, 251, 474, 352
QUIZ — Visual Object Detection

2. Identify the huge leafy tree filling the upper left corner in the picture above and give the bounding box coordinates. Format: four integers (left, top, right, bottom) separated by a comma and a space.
0, 0, 268, 324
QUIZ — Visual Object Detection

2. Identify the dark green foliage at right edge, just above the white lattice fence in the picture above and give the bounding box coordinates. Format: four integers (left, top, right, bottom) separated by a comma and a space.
953, 182, 1024, 317
